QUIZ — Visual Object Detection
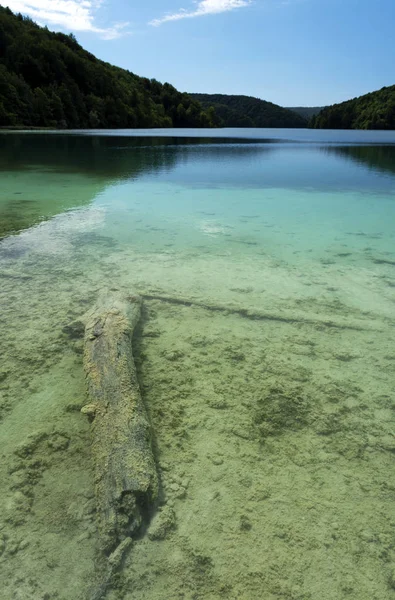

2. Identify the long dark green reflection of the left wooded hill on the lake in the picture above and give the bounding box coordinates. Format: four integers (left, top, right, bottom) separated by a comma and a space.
0, 133, 269, 239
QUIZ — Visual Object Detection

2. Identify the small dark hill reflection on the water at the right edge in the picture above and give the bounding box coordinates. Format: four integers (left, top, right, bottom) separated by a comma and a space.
326, 146, 395, 180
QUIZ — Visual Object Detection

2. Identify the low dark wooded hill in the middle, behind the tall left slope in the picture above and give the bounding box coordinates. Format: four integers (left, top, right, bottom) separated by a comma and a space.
190, 94, 307, 127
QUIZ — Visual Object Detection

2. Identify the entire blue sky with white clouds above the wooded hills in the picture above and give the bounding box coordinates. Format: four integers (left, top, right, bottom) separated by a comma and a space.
2, 0, 395, 106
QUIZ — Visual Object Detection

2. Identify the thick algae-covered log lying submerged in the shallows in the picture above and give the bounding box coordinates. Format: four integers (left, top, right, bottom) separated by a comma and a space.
83, 296, 158, 554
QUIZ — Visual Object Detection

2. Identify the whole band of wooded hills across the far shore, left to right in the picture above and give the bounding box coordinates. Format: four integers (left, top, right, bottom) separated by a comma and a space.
9, 6, 395, 129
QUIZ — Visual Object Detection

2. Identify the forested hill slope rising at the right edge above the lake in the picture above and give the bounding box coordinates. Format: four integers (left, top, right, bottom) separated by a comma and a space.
310, 85, 395, 129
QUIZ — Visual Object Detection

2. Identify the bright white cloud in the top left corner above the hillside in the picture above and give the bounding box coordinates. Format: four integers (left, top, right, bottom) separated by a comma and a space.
4, 0, 128, 39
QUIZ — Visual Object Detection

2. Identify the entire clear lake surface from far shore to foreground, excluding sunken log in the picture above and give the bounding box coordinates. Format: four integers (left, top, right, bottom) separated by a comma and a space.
0, 130, 395, 600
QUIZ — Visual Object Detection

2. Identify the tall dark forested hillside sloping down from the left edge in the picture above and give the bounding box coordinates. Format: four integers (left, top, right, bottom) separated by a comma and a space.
0, 7, 219, 128
